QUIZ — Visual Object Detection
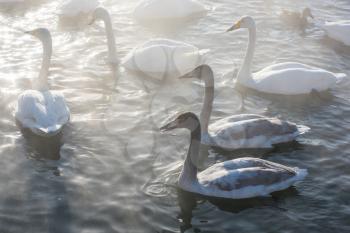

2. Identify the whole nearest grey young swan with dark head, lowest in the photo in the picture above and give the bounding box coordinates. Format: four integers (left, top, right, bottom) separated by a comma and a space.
161, 113, 307, 199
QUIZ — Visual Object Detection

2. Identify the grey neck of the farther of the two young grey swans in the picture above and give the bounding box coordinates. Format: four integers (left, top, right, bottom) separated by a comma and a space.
200, 70, 214, 134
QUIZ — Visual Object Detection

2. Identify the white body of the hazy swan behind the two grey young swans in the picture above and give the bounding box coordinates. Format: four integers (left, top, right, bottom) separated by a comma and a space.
122, 39, 205, 80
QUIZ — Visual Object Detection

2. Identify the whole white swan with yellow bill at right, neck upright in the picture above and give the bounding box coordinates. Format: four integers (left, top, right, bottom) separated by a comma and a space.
227, 16, 346, 95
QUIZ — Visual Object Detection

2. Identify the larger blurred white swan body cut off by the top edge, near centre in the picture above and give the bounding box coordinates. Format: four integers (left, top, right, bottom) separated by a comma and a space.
134, 0, 207, 21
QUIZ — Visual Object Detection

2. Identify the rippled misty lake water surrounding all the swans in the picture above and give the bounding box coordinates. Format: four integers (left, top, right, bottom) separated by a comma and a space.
0, 0, 350, 233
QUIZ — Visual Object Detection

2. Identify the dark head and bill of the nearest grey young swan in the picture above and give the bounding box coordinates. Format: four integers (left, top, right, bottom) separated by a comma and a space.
160, 112, 200, 132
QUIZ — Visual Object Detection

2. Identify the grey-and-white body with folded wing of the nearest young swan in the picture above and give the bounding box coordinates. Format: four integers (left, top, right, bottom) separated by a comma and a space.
198, 158, 307, 198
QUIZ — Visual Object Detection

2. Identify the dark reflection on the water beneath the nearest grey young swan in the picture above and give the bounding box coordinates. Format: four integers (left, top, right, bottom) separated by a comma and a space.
177, 186, 298, 233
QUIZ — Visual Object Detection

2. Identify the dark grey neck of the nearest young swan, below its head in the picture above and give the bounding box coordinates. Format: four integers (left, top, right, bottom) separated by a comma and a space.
179, 124, 201, 189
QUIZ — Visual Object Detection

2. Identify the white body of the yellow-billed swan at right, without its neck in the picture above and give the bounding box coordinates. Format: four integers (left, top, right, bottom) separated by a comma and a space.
252, 63, 345, 95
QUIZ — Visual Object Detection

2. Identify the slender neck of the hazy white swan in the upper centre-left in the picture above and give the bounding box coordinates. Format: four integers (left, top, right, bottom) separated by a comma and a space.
100, 10, 117, 64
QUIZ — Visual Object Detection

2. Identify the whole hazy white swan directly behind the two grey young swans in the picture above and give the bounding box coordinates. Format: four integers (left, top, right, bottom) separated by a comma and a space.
89, 7, 208, 80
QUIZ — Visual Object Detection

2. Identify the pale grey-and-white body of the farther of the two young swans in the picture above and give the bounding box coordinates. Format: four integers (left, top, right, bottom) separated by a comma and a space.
209, 117, 307, 149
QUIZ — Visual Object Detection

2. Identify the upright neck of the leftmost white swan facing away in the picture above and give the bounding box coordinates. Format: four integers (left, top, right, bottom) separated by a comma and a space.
38, 37, 52, 91
